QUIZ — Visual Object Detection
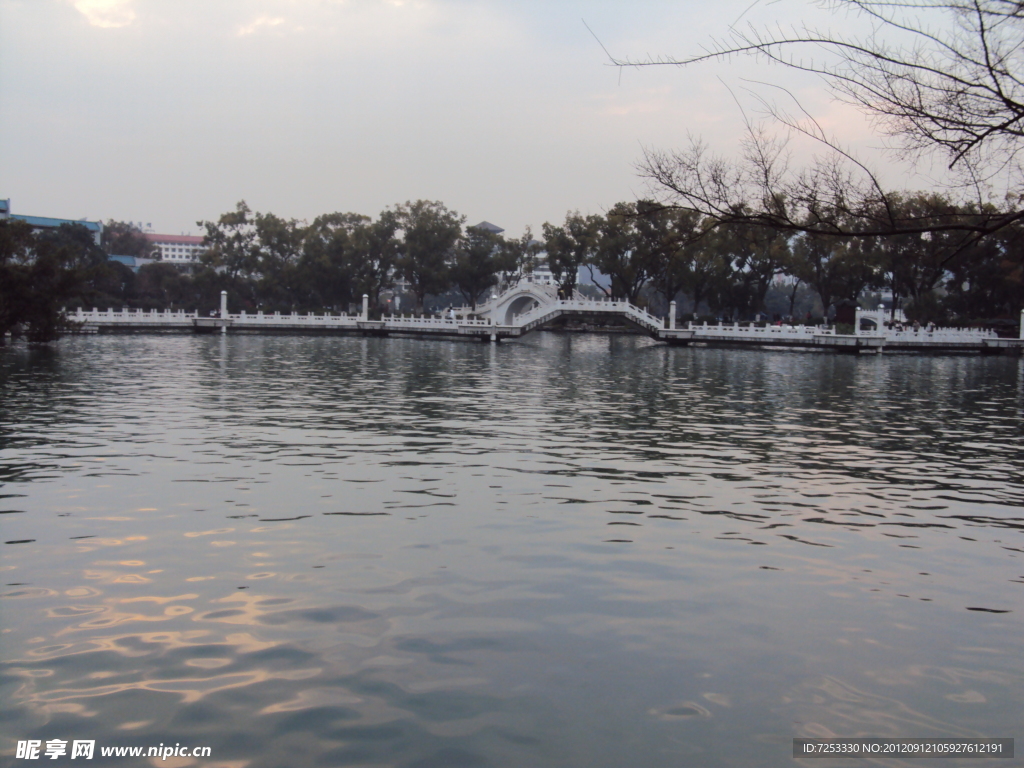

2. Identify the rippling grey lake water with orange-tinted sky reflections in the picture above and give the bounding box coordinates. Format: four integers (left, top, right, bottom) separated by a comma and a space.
0, 334, 1024, 768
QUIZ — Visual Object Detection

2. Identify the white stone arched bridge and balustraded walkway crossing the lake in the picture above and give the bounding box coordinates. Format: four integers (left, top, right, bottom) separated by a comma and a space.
69, 283, 1024, 354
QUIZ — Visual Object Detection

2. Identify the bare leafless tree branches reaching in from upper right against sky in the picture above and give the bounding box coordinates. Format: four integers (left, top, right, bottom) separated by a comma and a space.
611, 0, 1024, 247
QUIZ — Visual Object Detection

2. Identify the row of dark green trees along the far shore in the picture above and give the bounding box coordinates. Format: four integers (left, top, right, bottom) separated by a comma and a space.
0, 193, 1024, 342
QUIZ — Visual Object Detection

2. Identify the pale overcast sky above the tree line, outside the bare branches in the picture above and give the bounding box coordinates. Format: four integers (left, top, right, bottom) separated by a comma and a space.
0, 0, 913, 237
